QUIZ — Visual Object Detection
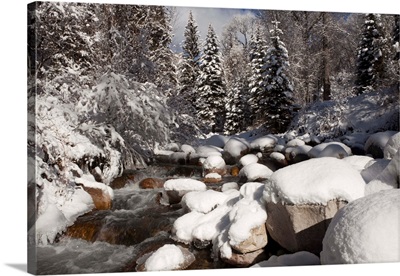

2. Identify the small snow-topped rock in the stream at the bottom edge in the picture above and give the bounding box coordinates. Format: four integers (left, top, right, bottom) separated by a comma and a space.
137, 244, 195, 271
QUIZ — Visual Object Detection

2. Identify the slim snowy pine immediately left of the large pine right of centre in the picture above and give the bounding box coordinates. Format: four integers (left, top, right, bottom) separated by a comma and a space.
248, 27, 266, 125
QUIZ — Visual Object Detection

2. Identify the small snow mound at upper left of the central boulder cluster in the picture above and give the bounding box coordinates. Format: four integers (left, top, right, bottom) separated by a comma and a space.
182, 190, 228, 213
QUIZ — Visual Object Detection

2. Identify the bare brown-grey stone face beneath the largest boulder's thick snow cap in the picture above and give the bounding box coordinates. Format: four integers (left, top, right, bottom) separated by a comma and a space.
266, 200, 346, 255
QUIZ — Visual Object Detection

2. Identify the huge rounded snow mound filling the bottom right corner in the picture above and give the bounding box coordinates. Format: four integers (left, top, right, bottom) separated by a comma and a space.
321, 189, 400, 264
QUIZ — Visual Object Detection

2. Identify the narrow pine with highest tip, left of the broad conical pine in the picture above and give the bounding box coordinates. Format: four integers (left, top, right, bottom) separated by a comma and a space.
179, 11, 200, 108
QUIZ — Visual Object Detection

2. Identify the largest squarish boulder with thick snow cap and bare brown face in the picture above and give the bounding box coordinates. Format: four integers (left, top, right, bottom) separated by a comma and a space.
263, 157, 365, 254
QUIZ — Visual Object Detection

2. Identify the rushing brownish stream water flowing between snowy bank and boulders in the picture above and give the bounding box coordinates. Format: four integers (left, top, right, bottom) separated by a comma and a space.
37, 166, 236, 274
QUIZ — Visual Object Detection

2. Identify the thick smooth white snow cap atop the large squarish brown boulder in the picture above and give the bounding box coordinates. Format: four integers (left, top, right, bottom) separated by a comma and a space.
264, 157, 365, 205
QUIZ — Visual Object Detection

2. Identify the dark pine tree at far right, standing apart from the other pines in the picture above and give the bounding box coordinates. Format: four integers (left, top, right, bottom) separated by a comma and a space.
356, 13, 385, 94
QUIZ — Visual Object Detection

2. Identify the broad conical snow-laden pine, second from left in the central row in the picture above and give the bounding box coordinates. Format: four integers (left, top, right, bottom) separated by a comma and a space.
196, 24, 226, 132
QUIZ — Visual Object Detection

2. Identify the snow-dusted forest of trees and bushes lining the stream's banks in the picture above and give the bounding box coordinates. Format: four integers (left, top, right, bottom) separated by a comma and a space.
27, 2, 400, 274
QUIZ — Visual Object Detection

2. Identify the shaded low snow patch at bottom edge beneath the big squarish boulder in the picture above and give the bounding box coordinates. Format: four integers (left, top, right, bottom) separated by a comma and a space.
251, 251, 320, 268
